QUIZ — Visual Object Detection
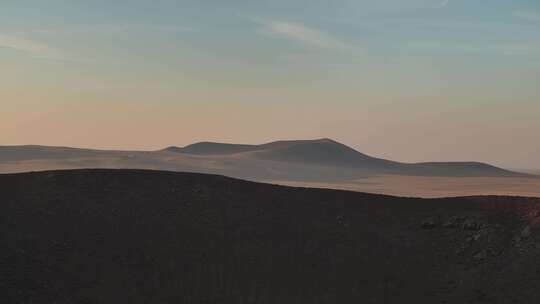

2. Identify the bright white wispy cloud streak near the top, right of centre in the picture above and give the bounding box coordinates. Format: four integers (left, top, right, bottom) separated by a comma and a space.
258, 21, 360, 51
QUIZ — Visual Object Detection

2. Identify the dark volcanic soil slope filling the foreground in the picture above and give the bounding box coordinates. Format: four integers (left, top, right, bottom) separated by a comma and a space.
0, 170, 540, 304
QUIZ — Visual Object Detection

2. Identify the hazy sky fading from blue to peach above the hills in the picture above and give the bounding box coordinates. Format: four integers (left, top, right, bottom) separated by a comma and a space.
0, 0, 540, 169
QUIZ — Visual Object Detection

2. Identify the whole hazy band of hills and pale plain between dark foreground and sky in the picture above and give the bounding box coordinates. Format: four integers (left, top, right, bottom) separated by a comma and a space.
0, 139, 540, 197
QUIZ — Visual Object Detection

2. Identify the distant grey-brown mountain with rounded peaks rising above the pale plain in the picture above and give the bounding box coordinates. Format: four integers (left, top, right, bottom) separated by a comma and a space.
165, 138, 526, 176
